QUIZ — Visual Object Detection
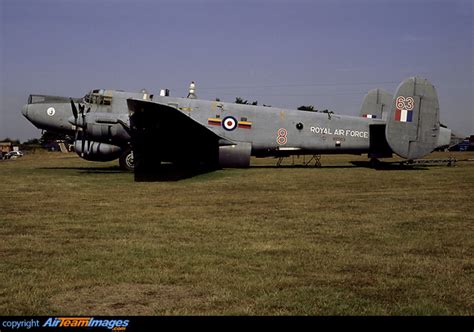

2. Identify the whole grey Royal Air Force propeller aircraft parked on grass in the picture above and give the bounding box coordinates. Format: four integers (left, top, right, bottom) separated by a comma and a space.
23, 77, 451, 180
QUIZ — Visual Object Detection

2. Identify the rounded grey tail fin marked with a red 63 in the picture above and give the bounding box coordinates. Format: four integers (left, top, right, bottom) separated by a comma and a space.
385, 77, 440, 159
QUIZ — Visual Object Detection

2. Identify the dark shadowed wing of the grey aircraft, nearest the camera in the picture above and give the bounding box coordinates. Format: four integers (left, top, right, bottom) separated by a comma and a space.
127, 99, 232, 178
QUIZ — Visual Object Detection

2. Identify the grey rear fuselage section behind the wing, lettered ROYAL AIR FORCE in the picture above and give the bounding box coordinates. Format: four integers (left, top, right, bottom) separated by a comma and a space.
148, 97, 378, 156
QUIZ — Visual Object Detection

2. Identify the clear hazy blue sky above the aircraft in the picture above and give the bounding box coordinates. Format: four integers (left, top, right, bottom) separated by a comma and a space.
0, 0, 474, 141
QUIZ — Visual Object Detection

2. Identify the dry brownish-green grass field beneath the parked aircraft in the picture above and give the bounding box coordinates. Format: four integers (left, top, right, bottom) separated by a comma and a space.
0, 153, 474, 315
